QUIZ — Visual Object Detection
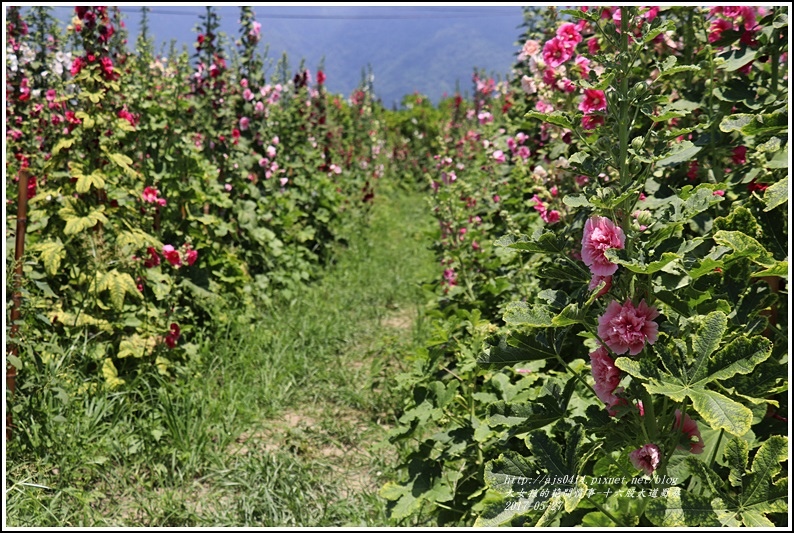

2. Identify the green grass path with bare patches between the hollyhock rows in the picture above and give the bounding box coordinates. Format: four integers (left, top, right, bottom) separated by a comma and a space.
5, 189, 435, 526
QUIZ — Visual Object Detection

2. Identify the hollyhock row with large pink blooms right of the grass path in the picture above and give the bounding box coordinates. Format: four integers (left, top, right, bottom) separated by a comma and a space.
381, 7, 789, 527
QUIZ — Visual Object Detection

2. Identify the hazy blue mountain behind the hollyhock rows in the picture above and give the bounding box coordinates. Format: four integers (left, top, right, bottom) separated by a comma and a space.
40, 5, 523, 107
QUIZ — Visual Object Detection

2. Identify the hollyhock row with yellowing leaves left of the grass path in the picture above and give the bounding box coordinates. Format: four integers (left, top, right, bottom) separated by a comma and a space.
6, 7, 386, 389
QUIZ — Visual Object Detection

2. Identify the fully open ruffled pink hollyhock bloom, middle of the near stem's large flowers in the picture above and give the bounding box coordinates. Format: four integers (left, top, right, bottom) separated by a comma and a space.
598, 299, 659, 355
